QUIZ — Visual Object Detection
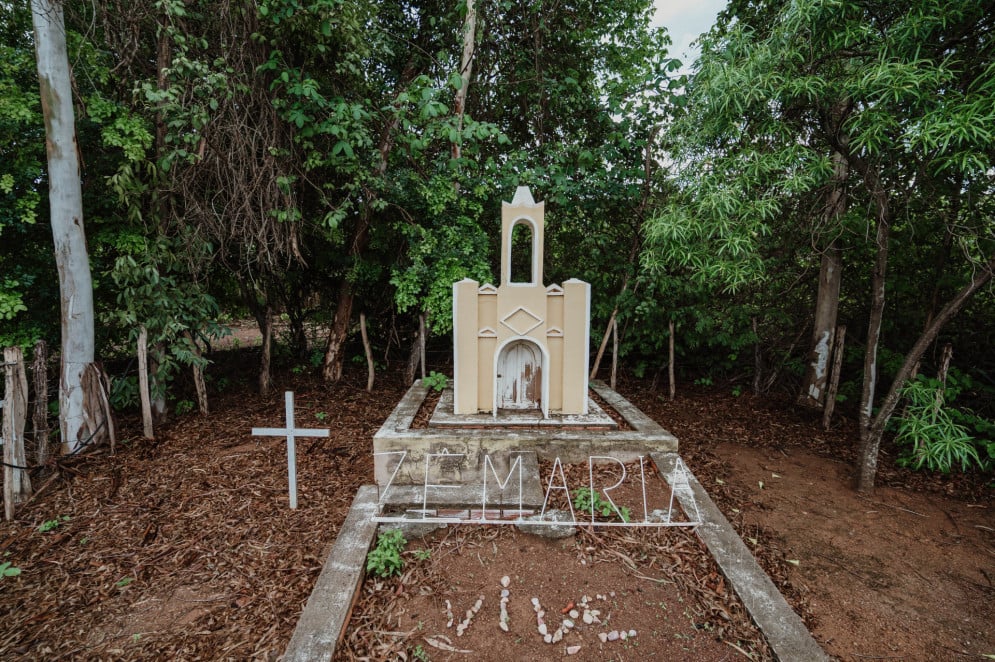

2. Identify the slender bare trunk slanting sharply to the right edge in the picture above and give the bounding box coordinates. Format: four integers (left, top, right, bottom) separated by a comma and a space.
857, 257, 995, 493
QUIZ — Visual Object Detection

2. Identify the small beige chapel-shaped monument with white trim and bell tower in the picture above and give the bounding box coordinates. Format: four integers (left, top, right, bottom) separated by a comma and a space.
453, 186, 591, 418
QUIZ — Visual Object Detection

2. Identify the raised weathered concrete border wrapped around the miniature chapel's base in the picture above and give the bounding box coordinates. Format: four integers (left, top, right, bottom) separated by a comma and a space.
373, 382, 677, 486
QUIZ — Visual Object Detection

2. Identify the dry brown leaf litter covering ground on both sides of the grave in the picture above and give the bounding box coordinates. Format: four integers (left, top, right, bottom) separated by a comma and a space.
0, 358, 991, 660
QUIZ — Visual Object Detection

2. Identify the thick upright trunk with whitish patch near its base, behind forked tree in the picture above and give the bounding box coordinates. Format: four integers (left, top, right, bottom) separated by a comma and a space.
798, 241, 843, 408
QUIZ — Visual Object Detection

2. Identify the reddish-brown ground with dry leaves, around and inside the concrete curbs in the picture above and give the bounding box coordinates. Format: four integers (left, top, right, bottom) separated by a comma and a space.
0, 349, 995, 661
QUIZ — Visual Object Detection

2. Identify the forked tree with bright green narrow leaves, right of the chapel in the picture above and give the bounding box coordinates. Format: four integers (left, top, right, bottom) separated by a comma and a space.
653, 0, 995, 491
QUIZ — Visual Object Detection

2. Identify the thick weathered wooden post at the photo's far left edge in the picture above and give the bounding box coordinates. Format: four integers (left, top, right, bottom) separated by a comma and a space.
3, 347, 31, 520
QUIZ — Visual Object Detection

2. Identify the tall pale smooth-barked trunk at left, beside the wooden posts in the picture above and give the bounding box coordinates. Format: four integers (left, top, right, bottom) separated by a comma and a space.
31, 0, 94, 452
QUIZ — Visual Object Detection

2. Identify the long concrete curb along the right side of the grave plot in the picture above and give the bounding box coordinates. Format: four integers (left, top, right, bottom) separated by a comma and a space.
648, 454, 829, 662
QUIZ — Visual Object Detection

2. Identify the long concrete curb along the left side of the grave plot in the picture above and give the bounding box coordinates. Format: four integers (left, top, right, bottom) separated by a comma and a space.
283, 485, 377, 662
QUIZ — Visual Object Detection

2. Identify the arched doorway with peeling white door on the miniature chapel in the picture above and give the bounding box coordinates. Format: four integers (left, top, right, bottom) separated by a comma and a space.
493, 337, 549, 418
